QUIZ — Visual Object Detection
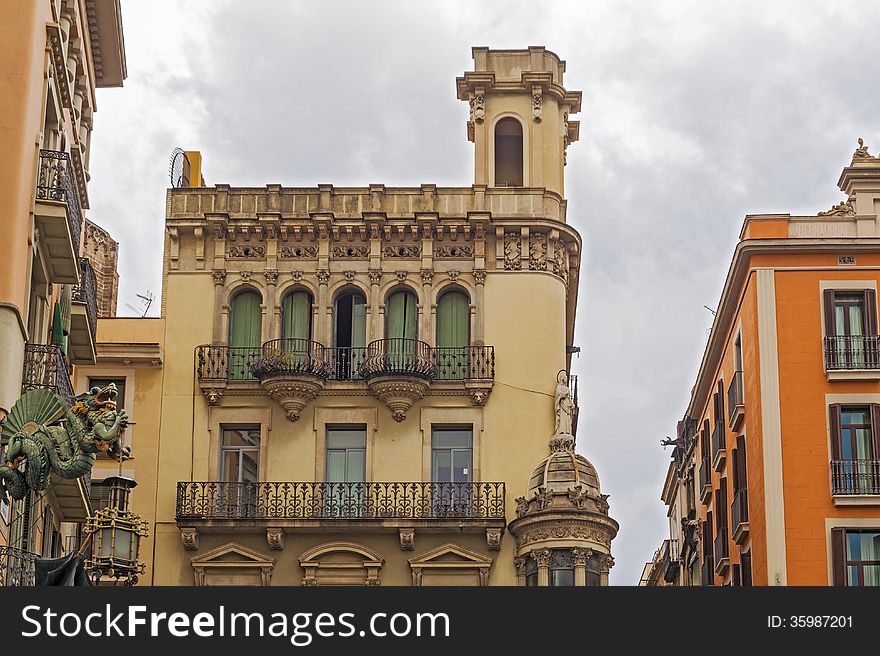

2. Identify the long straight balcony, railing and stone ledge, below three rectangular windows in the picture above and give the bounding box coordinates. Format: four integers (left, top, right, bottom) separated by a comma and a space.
176, 481, 506, 532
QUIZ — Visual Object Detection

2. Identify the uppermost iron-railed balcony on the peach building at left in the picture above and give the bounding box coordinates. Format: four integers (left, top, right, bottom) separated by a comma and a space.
34, 150, 83, 285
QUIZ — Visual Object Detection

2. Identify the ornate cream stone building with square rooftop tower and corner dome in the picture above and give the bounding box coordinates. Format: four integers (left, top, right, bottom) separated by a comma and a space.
86, 47, 617, 585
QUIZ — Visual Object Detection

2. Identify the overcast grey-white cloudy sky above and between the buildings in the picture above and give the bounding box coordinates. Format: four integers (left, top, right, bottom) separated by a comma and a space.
89, 0, 880, 585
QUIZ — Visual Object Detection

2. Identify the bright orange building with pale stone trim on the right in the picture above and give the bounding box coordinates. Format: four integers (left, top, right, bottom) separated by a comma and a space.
655, 141, 880, 585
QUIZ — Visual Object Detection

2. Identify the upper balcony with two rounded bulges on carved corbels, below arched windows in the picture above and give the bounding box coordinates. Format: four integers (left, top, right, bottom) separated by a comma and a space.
196, 338, 495, 420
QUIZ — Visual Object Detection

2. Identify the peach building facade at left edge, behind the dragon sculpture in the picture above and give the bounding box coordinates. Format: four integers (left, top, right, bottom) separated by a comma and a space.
0, 0, 126, 585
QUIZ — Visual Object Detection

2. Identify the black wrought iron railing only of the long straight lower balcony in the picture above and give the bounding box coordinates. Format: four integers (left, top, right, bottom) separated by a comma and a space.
177, 482, 505, 521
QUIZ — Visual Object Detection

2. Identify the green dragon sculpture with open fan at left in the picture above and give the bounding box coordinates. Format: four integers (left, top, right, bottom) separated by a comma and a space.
0, 383, 128, 499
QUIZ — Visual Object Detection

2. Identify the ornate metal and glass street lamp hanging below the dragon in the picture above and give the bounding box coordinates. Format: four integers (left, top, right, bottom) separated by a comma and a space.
85, 476, 148, 585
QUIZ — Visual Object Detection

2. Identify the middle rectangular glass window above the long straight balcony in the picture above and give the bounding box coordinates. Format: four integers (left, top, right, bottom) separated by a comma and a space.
323, 426, 367, 517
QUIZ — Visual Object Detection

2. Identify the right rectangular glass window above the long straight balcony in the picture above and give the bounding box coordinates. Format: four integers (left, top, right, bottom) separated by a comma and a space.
431, 426, 473, 516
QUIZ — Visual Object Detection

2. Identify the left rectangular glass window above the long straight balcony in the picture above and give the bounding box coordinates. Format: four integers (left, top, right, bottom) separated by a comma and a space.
217, 426, 260, 517
